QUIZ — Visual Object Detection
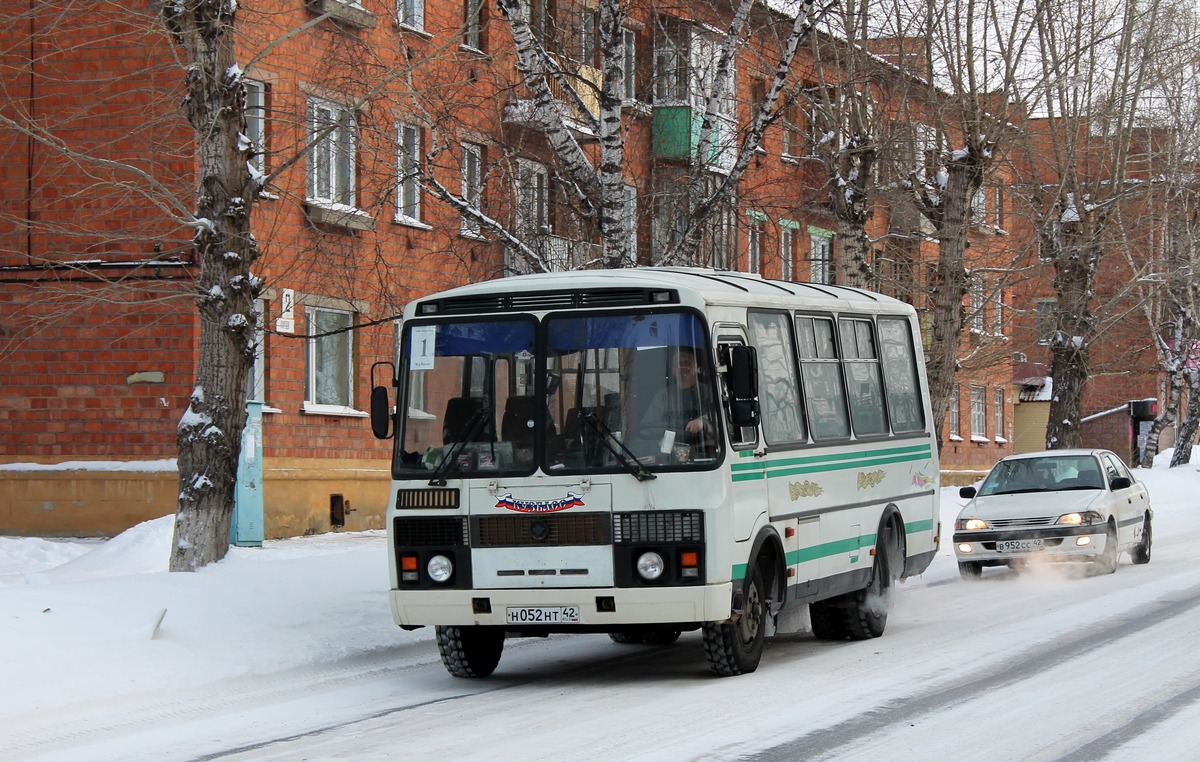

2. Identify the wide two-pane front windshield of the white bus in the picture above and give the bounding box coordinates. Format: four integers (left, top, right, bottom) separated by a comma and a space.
394, 311, 721, 480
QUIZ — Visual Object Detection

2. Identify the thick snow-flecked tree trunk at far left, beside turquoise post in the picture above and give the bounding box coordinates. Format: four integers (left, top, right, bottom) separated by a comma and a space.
161, 0, 262, 571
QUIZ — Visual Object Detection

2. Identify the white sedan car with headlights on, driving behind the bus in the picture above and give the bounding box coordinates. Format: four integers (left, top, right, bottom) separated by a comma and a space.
954, 450, 1153, 580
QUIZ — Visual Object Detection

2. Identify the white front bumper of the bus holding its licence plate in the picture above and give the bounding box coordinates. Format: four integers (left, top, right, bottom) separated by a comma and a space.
388, 582, 733, 632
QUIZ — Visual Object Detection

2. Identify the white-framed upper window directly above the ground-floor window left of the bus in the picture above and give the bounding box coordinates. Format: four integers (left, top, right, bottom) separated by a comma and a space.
308, 100, 356, 209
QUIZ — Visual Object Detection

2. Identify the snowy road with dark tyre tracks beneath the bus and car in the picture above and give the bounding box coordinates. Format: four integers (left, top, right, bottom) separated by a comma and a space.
7, 470, 1200, 762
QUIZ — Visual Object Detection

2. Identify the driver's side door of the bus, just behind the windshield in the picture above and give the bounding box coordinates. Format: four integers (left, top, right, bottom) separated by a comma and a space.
716, 324, 767, 544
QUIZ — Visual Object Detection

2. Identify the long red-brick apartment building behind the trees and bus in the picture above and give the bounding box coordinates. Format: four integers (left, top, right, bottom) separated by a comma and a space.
0, 0, 1089, 536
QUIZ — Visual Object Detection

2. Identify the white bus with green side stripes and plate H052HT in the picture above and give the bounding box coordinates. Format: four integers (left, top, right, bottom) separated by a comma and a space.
371, 268, 940, 677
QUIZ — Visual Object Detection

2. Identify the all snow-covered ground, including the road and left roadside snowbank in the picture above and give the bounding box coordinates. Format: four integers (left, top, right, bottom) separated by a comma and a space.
0, 454, 1200, 760
